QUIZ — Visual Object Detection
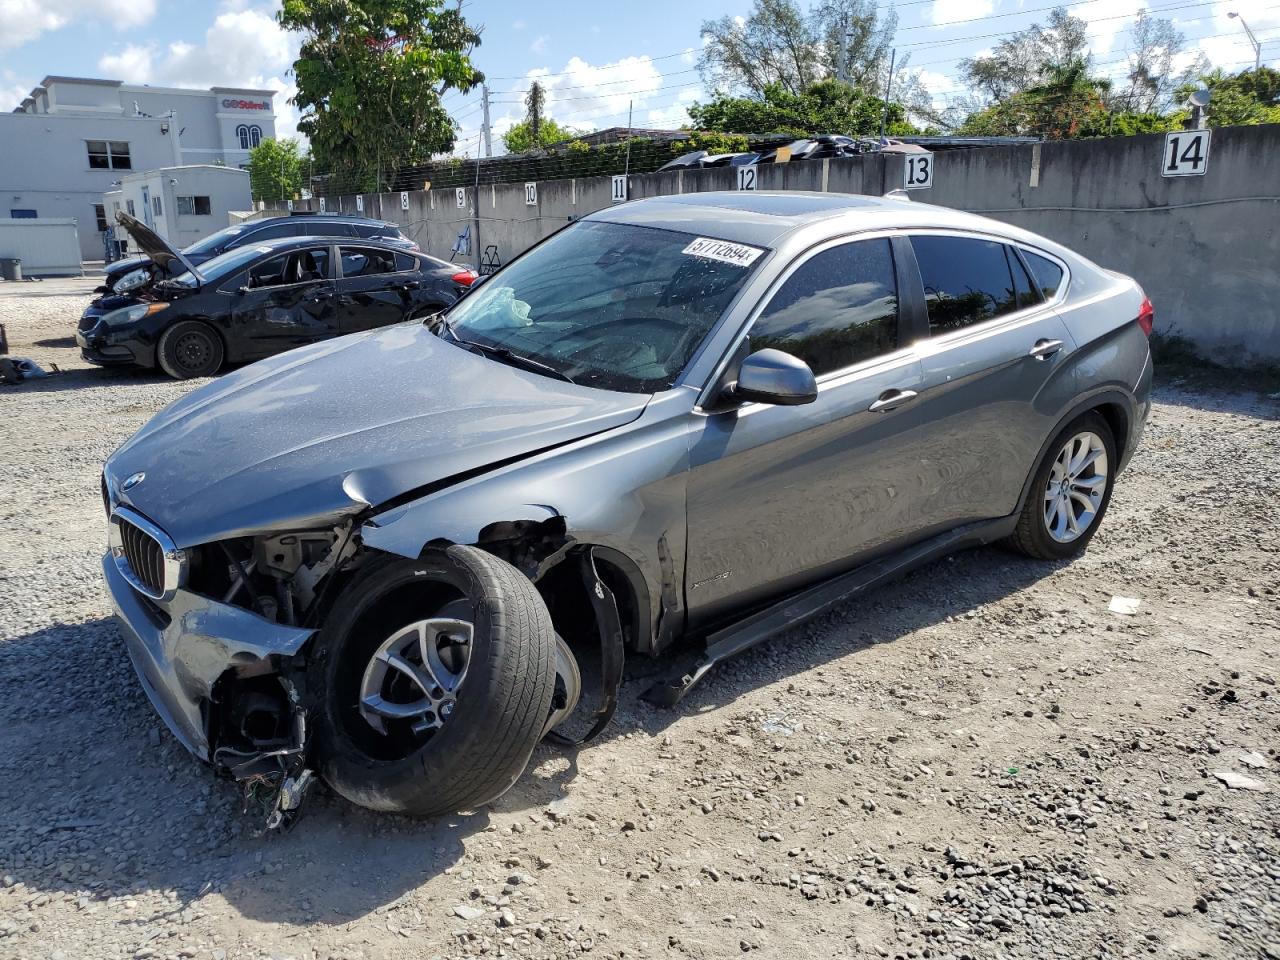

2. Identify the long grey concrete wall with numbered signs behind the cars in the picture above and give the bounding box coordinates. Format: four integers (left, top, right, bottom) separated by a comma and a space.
277, 125, 1280, 364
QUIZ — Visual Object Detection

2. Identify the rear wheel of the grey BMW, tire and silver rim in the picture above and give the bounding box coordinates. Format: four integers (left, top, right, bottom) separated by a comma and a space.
1006, 412, 1117, 561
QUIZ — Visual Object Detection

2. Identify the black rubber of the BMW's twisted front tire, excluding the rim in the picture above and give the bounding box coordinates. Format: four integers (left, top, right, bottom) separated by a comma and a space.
307, 547, 556, 817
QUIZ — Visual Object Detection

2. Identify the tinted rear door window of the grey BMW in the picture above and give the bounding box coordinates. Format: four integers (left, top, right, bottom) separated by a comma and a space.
911, 237, 1018, 337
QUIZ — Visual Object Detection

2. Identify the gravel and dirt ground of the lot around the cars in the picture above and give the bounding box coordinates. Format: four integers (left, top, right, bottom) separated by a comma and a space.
0, 280, 1280, 960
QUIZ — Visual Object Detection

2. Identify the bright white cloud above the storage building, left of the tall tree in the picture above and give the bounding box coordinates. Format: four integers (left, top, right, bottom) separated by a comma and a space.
97, 0, 300, 137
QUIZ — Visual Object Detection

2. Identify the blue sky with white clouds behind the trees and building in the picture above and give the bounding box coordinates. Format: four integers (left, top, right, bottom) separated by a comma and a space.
0, 0, 1280, 156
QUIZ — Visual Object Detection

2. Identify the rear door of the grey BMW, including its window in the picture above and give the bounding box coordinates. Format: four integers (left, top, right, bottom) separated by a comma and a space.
910, 232, 1075, 527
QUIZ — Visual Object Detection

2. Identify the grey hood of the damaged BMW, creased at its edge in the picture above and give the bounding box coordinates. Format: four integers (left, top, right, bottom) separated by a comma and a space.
106, 323, 649, 547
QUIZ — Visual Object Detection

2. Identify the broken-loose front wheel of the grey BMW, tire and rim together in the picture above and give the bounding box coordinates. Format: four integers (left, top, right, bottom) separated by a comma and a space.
308, 547, 556, 817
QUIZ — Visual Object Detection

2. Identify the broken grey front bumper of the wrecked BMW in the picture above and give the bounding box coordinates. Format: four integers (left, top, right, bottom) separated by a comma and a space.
102, 553, 315, 760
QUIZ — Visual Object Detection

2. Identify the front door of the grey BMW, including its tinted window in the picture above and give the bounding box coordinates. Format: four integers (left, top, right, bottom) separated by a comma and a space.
685, 237, 927, 625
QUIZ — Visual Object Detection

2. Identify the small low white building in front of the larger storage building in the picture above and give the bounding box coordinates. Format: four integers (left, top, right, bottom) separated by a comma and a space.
102, 164, 253, 253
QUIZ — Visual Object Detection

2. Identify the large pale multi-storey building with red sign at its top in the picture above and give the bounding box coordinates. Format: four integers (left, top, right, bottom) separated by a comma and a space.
0, 77, 275, 260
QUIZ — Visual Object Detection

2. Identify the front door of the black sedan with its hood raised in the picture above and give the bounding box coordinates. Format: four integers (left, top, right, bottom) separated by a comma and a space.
232, 246, 338, 358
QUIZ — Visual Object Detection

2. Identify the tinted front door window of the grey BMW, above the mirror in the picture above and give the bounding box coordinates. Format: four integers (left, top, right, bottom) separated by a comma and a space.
751, 239, 897, 375
